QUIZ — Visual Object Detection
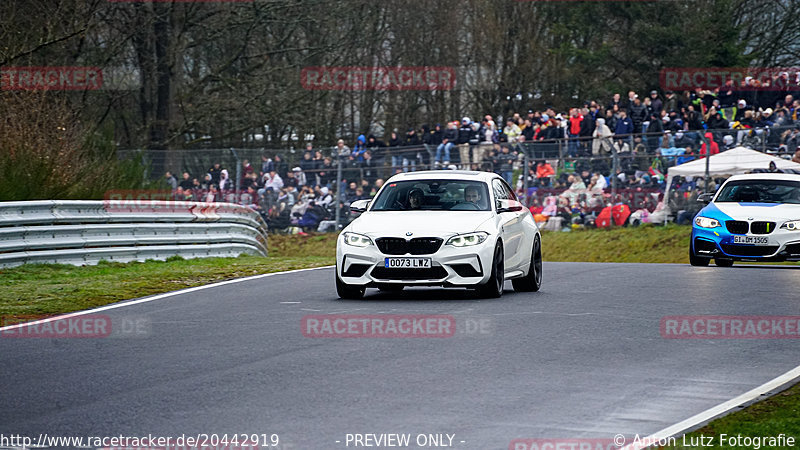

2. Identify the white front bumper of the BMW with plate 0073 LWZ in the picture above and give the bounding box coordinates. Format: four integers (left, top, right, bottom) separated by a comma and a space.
336, 235, 496, 287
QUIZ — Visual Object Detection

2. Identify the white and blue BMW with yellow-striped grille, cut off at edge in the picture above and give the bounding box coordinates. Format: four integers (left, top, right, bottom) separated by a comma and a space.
689, 173, 800, 267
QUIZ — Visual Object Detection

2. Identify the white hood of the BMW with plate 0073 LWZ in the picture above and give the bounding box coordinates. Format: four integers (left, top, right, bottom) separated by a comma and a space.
347, 211, 493, 237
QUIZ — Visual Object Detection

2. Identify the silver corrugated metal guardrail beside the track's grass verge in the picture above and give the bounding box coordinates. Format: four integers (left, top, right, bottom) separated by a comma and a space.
0, 200, 267, 267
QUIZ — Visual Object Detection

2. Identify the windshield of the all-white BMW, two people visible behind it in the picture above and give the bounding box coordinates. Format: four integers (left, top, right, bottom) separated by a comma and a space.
370, 180, 490, 211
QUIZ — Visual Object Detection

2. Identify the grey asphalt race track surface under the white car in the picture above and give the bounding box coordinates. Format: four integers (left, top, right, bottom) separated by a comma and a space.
0, 263, 800, 449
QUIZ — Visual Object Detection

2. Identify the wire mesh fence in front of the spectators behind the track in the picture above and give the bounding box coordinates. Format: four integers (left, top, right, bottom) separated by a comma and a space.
119, 126, 800, 230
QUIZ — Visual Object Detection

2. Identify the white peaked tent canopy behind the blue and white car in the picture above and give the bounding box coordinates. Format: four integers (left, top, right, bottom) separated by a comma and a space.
667, 147, 800, 189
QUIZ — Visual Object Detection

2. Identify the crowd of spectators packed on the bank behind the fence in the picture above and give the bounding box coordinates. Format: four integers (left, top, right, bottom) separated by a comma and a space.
161, 85, 800, 231
